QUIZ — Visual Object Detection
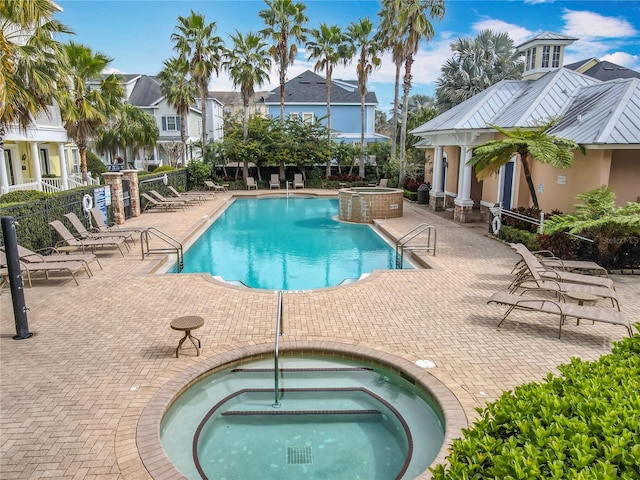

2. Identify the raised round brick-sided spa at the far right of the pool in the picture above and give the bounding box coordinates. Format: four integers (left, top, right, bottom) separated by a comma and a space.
338, 187, 403, 223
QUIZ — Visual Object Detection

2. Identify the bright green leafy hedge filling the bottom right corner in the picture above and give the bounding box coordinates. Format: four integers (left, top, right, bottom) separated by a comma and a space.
431, 334, 640, 480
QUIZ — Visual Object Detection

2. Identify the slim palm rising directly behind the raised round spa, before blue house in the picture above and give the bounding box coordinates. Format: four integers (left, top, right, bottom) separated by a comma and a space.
347, 17, 380, 178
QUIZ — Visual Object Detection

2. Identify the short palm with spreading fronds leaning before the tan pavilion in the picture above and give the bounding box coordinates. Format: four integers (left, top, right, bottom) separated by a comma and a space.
468, 119, 584, 210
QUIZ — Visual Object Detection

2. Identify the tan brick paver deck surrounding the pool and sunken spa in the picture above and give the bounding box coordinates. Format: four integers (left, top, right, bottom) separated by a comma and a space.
0, 190, 640, 480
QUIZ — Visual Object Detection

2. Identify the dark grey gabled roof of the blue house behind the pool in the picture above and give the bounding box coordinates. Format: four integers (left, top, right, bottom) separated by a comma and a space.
265, 70, 378, 105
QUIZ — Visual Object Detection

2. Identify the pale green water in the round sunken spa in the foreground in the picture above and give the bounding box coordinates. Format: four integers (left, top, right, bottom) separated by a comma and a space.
160, 357, 444, 480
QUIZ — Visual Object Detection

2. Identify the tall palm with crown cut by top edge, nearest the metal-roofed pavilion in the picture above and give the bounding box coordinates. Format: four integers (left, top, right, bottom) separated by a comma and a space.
398, 0, 445, 187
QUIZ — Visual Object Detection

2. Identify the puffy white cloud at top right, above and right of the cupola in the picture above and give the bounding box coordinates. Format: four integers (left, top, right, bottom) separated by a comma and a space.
562, 9, 638, 40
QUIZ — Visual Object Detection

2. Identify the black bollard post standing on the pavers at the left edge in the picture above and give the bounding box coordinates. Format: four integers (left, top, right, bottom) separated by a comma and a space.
1, 217, 33, 340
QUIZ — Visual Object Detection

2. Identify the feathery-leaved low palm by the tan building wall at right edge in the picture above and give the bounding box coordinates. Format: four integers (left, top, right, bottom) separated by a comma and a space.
544, 187, 640, 261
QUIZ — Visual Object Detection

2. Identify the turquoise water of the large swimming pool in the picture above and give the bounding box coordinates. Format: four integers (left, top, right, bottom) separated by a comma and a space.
175, 197, 411, 290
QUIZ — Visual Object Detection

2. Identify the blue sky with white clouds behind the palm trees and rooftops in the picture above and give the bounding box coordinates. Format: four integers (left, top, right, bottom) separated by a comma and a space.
56, 0, 640, 111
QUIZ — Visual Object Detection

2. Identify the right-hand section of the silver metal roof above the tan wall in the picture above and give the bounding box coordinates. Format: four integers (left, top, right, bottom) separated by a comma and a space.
549, 78, 640, 145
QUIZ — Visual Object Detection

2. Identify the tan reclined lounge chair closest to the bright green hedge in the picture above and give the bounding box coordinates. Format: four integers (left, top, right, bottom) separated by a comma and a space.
487, 289, 632, 338
